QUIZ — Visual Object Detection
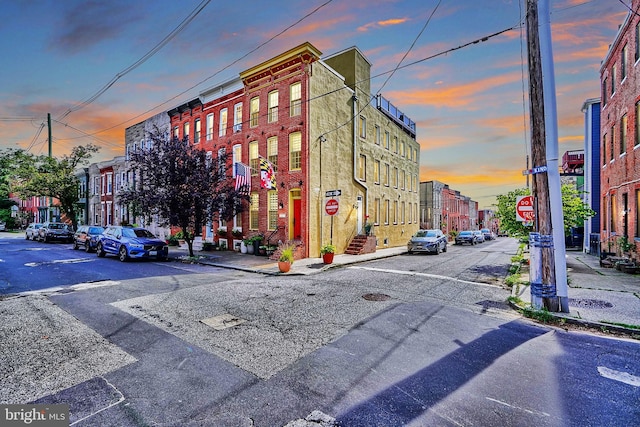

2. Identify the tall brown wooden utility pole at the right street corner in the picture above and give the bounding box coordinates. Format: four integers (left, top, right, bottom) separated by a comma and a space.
527, 0, 558, 311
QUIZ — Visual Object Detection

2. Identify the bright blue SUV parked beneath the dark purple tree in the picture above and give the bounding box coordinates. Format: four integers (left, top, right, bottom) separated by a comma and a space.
96, 226, 169, 262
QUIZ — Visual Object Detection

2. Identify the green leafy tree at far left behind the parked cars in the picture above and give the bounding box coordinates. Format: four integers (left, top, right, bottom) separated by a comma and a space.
10, 144, 99, 232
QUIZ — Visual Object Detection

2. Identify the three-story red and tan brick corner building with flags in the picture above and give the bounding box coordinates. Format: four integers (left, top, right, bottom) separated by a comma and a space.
162, 43, 420, 257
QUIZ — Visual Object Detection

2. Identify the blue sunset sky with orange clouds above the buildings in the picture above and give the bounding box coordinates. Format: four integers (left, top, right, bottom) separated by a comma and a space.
0, 0, 631, 209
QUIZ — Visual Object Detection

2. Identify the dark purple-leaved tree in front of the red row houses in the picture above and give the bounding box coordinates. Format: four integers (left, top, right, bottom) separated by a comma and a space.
119, 129, 249, 256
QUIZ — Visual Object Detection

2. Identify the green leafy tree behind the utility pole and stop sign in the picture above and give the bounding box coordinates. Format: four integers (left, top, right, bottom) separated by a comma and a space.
496, 184, 595, 236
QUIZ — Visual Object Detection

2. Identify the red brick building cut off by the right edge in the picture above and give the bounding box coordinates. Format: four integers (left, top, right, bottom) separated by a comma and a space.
600, 0, 640, 254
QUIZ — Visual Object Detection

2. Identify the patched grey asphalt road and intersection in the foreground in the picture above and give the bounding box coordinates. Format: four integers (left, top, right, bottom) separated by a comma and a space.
0, 239, 640, 427
